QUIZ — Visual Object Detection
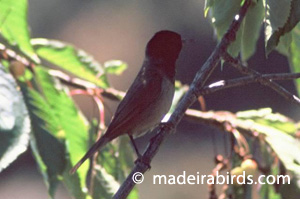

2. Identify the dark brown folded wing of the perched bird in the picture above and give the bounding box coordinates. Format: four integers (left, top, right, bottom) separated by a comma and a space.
107, 67, 163, 139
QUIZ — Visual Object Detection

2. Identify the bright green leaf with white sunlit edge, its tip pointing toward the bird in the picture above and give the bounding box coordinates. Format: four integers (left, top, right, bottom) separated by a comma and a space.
31, 38, 109, 88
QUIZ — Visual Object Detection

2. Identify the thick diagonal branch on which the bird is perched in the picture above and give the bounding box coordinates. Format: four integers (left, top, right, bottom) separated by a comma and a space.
113, 0, 252, 199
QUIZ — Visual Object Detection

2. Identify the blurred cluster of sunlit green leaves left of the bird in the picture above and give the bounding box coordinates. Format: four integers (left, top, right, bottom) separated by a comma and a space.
0, 0, 137, 199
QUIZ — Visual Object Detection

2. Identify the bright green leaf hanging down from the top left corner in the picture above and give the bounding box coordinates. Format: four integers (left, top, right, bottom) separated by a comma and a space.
0, 0, 40, 63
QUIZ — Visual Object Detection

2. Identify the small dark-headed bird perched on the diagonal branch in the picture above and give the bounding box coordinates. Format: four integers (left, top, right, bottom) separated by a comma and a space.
70, 30, 182, 173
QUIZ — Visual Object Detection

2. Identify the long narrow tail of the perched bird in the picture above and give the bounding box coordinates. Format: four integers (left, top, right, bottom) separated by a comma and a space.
70, 136, 110, 174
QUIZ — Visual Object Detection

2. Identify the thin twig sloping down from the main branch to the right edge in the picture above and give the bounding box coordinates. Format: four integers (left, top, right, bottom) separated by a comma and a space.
222, 52, 300, 106
